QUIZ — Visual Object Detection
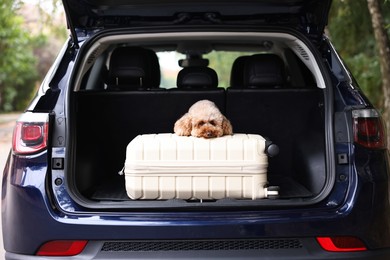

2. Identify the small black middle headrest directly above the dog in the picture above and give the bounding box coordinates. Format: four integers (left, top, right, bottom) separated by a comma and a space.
176, 67, 218, 89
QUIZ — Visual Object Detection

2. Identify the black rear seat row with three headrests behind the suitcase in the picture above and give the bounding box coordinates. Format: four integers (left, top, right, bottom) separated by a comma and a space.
74, 47, 321, 193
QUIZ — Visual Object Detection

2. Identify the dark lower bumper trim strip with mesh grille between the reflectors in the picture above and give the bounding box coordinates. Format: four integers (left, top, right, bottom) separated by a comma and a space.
6, 238, 390, 260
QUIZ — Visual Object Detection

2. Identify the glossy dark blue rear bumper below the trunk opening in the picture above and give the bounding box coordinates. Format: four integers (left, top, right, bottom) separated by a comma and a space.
3, 153, 390, 254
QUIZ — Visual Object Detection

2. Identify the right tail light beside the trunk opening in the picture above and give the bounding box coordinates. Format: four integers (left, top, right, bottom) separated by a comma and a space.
352, 109, 386, 149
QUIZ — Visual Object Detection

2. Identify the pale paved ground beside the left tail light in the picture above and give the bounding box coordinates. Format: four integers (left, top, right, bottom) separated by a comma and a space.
0, 113, 19, 259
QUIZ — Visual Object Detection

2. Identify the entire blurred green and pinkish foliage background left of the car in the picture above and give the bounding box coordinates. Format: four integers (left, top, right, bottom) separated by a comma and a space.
0, 0, 66, 112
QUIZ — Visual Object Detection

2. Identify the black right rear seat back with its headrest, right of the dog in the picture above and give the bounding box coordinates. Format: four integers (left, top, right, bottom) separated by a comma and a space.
226, 54, 323, 179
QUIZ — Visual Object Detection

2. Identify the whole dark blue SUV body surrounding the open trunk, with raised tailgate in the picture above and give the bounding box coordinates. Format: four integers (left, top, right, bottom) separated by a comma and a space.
2, 0, 390, 259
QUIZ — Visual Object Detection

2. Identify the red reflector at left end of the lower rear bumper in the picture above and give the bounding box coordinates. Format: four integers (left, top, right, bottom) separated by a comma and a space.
36, 240, 88, 256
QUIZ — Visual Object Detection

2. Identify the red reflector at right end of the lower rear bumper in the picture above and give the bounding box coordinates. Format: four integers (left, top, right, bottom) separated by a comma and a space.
317, 237, 367, 252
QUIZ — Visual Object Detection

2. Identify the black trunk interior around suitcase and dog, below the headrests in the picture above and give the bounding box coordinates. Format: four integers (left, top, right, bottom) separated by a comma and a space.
71, 89, 327, 202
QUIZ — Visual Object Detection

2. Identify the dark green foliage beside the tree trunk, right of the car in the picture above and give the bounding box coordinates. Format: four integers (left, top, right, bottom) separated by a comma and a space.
328, 0, 390, 108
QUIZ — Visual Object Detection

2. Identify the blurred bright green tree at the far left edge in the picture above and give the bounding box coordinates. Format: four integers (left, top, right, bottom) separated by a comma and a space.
0, 0, 37, 111
